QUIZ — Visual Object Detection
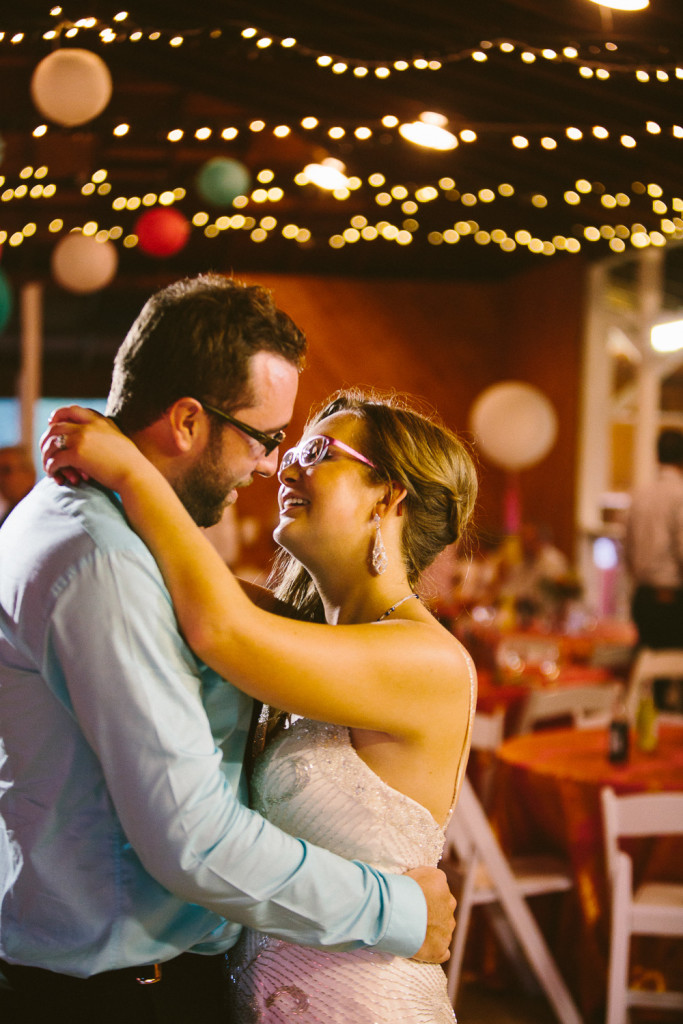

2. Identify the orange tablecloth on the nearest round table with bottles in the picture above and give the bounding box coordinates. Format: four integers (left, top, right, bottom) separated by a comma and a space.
492, 726, 683, 1021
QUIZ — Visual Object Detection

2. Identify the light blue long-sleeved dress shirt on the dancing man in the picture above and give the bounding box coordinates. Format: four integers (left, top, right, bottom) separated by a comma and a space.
0, 480, 426, 977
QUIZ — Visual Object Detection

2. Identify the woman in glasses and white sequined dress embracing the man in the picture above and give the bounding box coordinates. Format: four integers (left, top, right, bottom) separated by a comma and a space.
43, 391, 476, 1024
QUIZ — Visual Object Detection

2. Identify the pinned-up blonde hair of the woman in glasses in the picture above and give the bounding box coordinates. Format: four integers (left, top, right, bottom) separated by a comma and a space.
270, 388, 477, 620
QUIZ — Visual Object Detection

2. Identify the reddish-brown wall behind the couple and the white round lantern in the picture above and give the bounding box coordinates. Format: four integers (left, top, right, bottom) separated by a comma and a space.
240, 259, 584, 569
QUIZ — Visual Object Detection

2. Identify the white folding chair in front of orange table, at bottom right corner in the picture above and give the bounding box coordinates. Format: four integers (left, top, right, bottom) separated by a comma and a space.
600, 786, 683, 1024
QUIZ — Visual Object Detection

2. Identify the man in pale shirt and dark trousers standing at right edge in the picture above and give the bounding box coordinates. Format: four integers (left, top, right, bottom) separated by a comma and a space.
624, 430, 683, 648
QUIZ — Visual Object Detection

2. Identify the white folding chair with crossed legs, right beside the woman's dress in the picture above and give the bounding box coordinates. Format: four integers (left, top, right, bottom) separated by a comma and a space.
442, 778, 581, 1024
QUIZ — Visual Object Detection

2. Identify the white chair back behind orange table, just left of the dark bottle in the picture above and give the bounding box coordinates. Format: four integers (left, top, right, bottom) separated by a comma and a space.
517, 682, 621, 734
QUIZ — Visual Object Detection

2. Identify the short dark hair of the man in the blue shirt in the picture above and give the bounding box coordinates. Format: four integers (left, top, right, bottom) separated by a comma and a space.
106, 274, 306, 433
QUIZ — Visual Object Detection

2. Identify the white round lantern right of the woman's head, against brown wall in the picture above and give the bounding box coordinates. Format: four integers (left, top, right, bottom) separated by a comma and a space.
470, 381, 557, 470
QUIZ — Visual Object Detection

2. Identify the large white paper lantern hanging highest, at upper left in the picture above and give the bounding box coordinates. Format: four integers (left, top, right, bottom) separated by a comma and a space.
31, 49, 112, 127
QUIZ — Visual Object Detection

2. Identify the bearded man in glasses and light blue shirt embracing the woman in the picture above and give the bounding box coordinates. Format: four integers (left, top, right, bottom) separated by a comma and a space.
0, 275, 453, 1024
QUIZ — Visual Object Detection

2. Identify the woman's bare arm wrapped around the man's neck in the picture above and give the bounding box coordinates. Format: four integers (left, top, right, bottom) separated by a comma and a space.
43, 407, 468, 738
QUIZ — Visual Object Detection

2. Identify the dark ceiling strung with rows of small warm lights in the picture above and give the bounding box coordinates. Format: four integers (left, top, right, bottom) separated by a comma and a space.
0, 0, 683, 282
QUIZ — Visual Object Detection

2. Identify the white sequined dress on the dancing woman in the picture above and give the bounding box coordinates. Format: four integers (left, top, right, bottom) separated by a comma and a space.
230, 719, 455, 1024
